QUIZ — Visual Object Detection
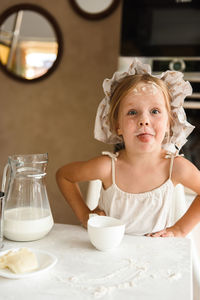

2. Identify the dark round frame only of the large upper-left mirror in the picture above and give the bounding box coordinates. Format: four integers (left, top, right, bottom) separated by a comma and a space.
0, 3, 63, 83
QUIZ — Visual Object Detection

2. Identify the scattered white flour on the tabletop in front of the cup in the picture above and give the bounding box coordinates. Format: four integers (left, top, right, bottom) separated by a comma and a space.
56, 258, 182, 299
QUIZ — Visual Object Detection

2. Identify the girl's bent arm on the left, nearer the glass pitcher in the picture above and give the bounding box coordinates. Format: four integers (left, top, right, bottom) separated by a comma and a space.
56, 156, 111, 228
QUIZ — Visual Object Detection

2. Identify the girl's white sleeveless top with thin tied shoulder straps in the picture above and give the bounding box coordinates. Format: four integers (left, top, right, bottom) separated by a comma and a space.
98, 152, 174, 235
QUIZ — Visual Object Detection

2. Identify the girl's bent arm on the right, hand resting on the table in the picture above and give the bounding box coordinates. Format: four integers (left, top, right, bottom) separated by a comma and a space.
151, 157, 200, 237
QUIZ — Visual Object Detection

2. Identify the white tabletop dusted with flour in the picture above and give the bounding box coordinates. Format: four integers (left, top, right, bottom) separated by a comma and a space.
0, 224, 192, 300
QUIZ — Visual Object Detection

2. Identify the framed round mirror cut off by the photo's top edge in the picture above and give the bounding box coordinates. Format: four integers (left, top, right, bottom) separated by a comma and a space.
70, 0, 120, 20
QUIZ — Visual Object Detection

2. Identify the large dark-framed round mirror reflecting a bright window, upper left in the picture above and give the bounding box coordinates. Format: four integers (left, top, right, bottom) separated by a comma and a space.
0, 4, 62, 82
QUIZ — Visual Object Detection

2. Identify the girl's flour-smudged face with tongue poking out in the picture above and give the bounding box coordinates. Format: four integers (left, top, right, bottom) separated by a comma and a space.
117, 82, 169, 152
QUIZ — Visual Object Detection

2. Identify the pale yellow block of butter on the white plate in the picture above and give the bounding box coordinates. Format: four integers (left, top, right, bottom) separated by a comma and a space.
0, 248, 38, 274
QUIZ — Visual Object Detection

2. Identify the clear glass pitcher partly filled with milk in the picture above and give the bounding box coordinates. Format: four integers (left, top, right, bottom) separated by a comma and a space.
2, 153, 54, 241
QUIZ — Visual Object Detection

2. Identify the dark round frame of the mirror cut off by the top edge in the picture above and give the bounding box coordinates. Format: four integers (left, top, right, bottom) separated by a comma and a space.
67, 0, 120, 21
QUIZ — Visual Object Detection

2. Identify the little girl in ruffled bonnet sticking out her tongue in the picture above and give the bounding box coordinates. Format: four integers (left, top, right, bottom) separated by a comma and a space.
57, 59, 200, 237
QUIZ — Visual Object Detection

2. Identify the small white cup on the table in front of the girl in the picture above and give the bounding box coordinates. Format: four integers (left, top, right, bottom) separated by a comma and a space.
88, 215, 125, 251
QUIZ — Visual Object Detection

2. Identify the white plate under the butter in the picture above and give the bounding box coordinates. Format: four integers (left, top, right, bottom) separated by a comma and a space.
0, 248, 57, 279
